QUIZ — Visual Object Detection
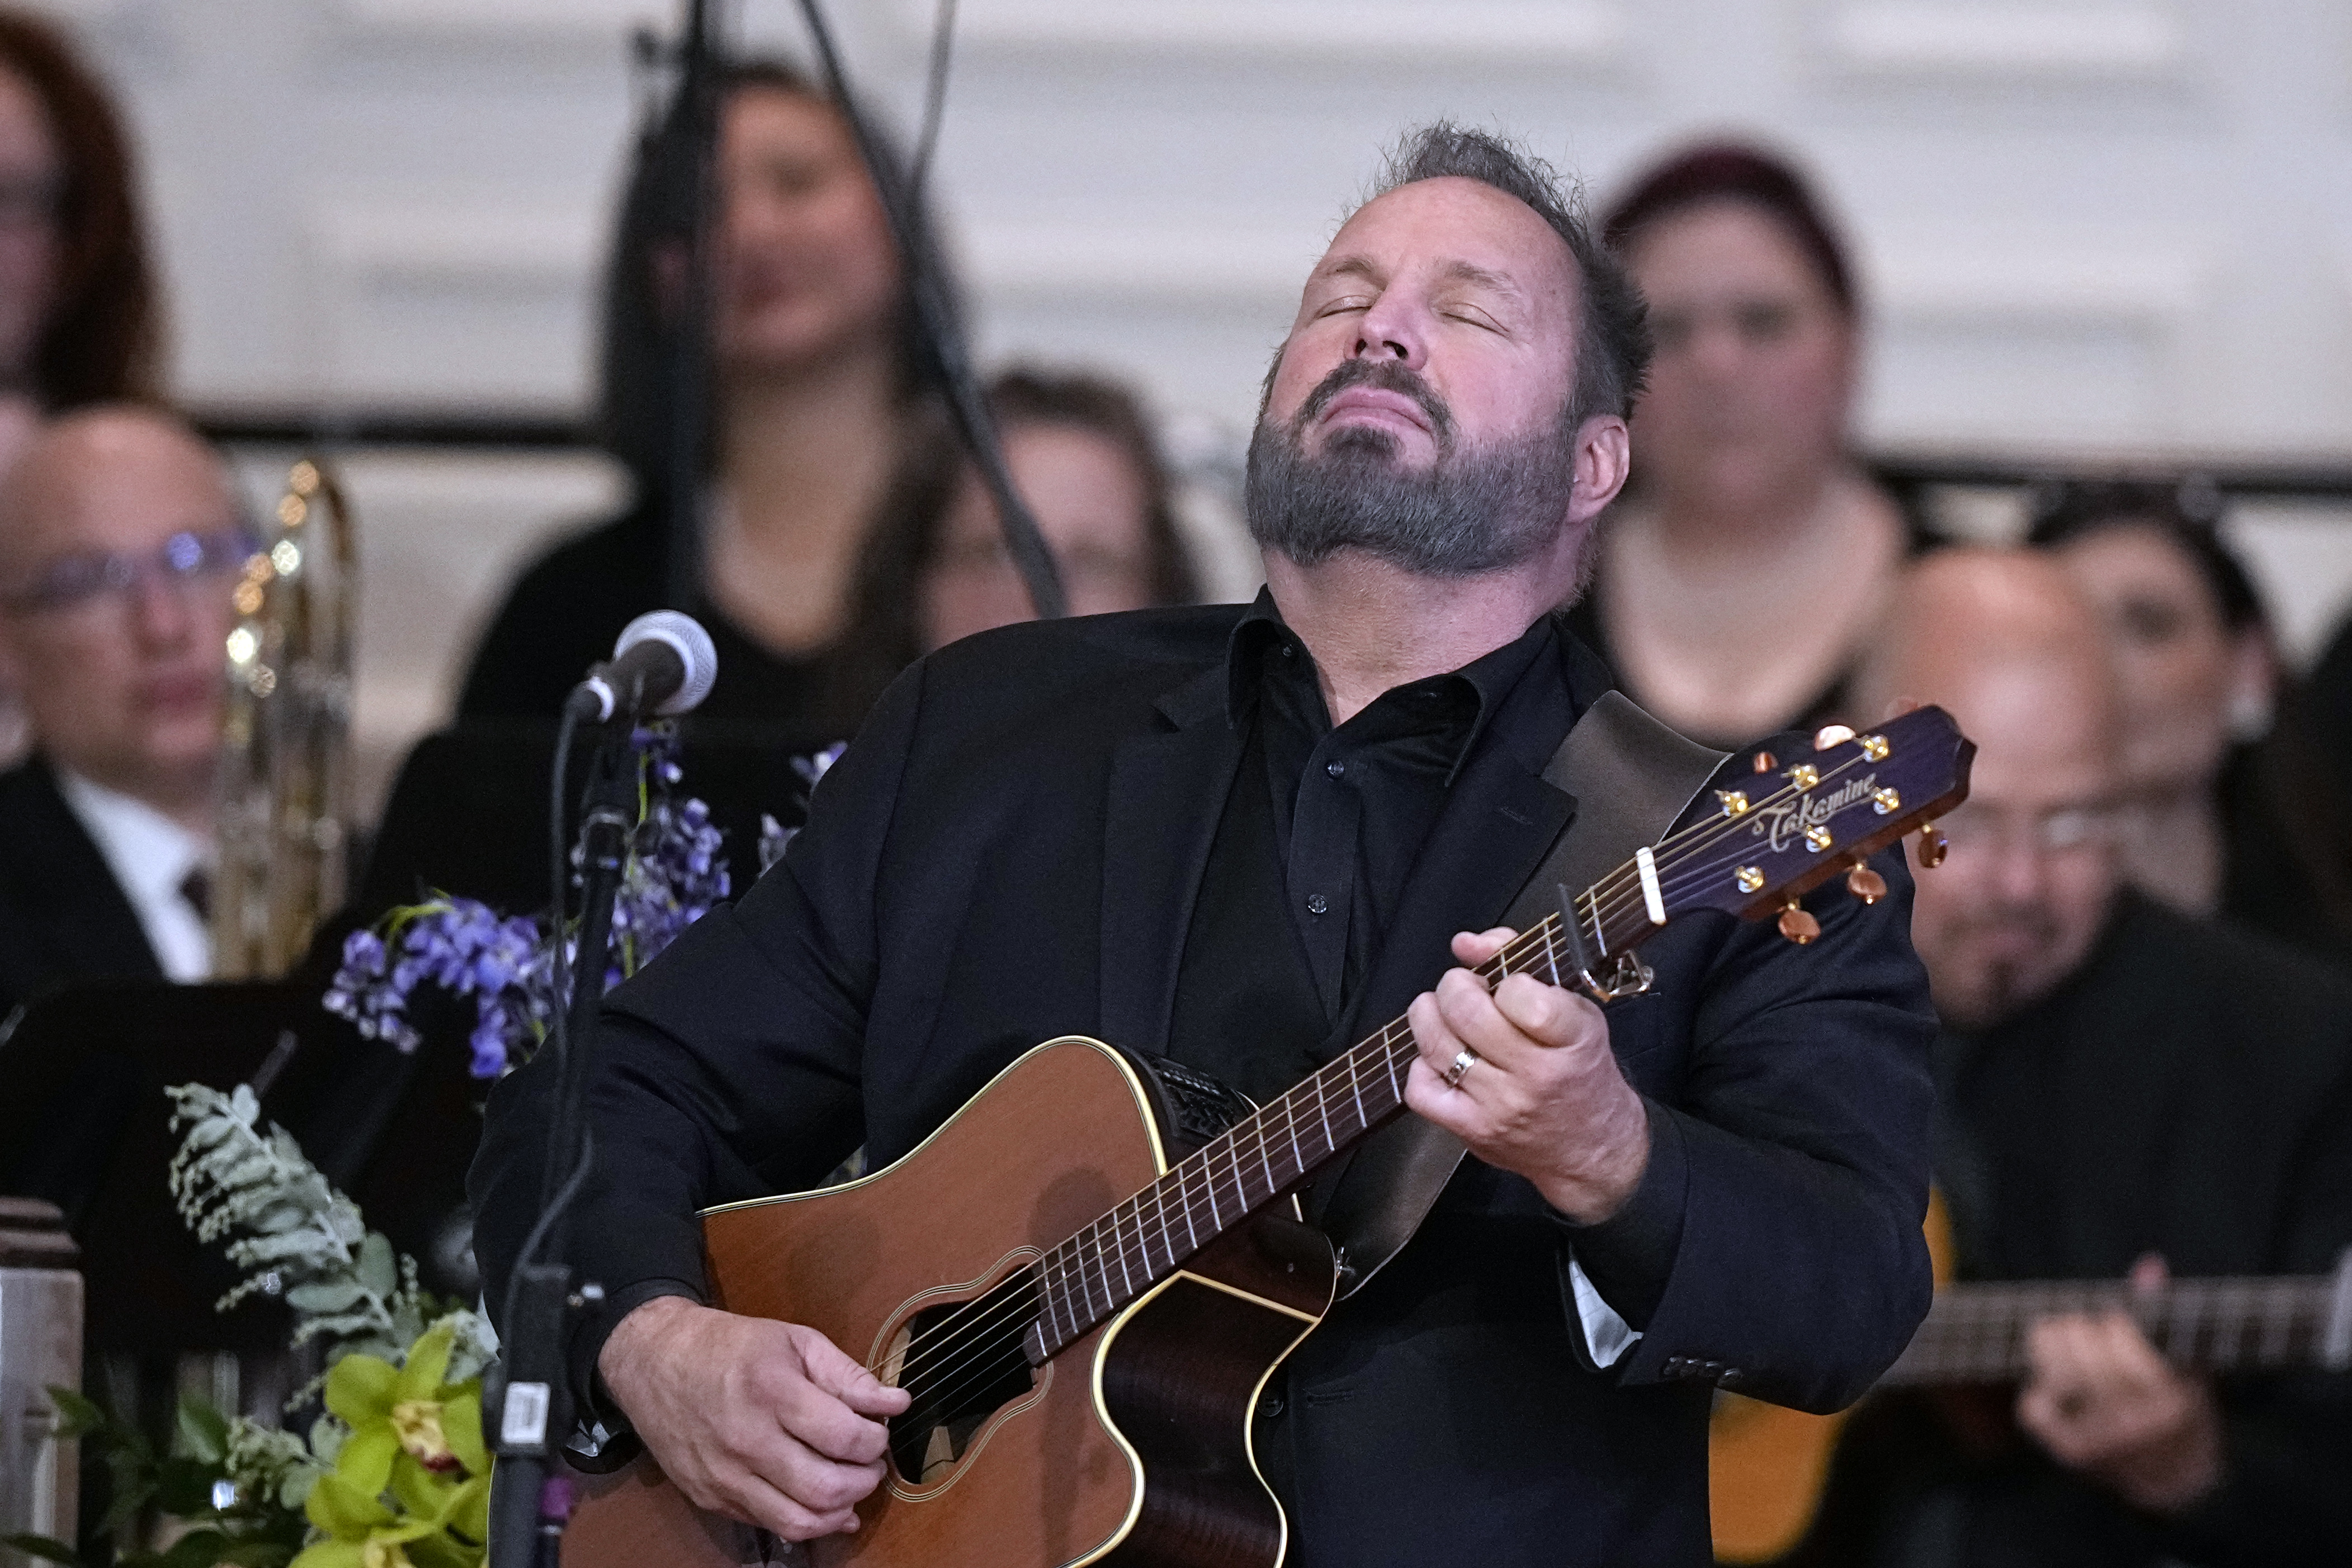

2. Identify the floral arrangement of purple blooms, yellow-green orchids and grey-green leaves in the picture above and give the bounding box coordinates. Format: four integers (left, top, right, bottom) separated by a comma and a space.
0, 726, 844, 1568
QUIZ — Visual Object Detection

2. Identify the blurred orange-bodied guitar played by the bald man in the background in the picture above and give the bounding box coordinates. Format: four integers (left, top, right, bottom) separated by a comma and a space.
1708, 1208, 2352, 1564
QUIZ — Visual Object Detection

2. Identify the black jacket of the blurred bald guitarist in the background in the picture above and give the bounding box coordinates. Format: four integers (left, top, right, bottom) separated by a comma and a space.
1806, 893, 2352, 1568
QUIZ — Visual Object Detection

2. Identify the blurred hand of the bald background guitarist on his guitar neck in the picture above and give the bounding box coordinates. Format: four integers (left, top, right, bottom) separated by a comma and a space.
2018, 1255, 2220, 1514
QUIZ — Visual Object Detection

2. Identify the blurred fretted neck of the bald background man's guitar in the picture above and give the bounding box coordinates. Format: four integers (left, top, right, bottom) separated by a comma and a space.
1879, 1267, 2352, 1385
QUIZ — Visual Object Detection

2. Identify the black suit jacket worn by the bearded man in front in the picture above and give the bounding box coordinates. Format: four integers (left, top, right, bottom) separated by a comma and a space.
473, 607, 1931, 1566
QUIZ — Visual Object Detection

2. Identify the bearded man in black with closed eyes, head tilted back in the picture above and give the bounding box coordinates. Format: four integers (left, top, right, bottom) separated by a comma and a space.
473, 127, 1931, 1568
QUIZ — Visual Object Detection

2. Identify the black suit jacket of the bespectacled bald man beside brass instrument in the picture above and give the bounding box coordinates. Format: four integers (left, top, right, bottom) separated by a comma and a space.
0, 757, 162, 1016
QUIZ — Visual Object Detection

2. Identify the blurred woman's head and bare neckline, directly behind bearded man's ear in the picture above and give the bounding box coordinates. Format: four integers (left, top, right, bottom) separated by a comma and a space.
1574, 146, 1912, 745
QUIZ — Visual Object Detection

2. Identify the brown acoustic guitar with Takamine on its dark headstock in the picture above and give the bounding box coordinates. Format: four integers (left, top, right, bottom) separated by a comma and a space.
564, 707, 1976, 1568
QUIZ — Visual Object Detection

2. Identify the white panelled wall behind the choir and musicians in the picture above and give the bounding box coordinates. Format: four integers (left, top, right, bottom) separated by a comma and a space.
27, 0, 2352, 809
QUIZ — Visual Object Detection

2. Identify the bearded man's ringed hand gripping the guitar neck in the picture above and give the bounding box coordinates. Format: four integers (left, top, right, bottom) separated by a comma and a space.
1404, 926, 1649, 1225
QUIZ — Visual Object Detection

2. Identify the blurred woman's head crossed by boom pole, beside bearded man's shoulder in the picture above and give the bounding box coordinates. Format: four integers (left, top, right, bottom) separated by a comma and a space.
844, 369, 1199, 701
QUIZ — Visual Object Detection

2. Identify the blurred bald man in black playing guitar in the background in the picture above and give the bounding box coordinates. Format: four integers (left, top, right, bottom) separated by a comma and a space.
1816, 550, 2352, 1568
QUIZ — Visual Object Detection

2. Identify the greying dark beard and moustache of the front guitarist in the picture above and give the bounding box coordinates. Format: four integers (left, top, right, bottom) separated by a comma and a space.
1246, 357, 1576, 576
